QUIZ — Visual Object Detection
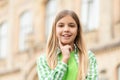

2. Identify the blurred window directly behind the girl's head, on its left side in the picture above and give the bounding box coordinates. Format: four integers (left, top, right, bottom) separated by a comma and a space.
46, 0, 57, 37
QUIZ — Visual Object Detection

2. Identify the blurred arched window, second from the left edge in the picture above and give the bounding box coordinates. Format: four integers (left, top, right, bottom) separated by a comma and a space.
19, 11, 33, 51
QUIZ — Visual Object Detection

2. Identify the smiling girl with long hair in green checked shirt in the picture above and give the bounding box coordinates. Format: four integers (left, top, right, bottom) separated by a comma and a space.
37, 10, 98, 80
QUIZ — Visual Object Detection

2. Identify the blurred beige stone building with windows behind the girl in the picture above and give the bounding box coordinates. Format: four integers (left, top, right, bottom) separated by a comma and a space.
0, 0, 120, 80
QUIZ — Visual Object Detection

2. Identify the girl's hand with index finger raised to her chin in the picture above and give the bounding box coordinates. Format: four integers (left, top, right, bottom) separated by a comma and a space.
59, 41, 72, 63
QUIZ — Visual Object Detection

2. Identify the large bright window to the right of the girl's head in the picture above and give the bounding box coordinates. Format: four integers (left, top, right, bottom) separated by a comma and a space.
81, 0, 99, 31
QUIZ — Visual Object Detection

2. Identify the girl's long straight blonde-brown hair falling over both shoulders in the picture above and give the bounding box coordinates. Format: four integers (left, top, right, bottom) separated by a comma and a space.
46, 10, 88, 80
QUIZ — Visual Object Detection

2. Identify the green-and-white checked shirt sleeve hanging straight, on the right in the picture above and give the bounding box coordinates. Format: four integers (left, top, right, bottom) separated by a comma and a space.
86, 52, 98, 80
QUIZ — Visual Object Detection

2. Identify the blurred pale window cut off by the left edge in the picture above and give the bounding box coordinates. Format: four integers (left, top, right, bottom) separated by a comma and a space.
0, 22, 8, 58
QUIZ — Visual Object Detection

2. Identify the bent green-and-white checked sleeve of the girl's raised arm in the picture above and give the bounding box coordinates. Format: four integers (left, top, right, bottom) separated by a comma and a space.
37, 56, 67, 80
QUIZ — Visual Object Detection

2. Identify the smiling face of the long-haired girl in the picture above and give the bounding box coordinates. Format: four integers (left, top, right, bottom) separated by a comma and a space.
56, 15, 78, 45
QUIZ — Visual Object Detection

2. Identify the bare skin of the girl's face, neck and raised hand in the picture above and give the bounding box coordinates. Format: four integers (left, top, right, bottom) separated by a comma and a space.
56, 15, 78, 63
